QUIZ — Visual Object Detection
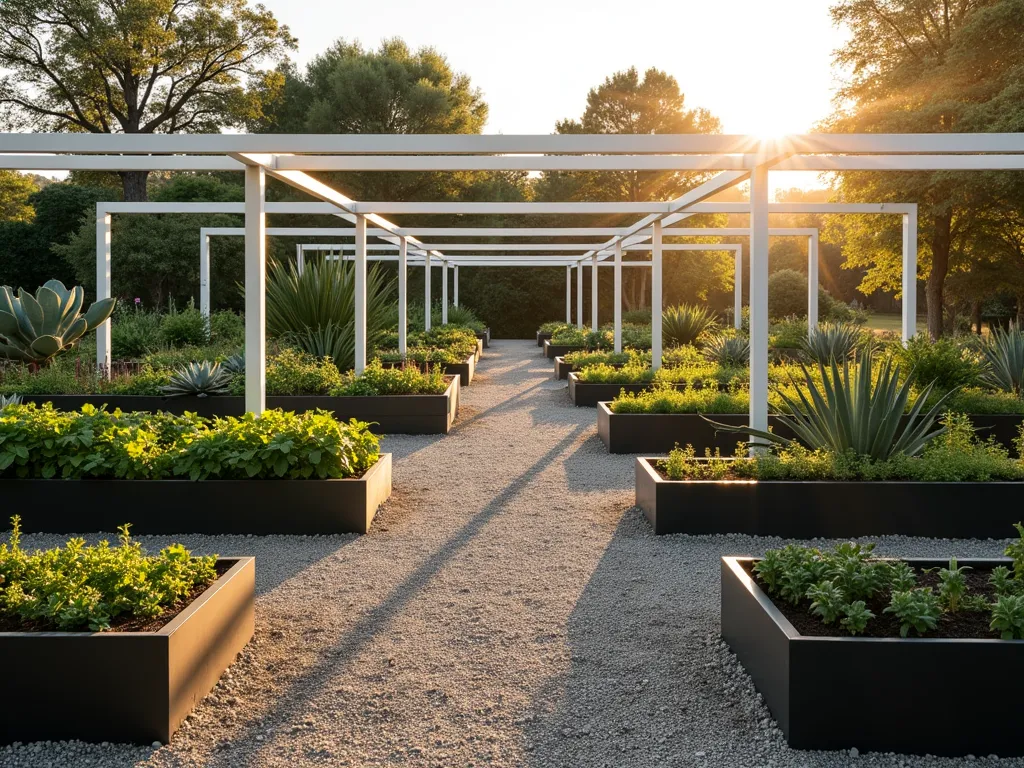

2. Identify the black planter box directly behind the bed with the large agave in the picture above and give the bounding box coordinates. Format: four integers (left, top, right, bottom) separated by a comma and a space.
602, 409, 1024, 456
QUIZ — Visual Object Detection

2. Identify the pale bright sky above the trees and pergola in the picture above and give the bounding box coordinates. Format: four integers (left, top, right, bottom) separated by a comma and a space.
263, 0, 845, 188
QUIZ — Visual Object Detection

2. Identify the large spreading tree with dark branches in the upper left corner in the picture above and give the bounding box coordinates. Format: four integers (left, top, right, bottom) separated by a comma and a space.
0, 0, 295, 201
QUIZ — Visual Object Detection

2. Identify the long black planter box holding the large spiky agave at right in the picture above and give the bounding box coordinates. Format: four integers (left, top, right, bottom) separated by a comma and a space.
636, 457, 1024, 539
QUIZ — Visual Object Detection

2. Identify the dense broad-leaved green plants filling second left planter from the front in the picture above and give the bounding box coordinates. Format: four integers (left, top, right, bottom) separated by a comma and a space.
0, 403, 380, 480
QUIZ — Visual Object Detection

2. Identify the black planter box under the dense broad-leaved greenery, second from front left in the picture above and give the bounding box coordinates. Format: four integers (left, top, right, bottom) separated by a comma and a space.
8, 454, 391, 536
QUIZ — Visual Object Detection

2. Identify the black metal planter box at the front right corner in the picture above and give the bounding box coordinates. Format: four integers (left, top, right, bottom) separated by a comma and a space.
722, 557, 1024, 757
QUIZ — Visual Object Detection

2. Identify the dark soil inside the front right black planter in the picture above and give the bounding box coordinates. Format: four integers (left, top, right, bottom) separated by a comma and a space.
741, 562, 999, 640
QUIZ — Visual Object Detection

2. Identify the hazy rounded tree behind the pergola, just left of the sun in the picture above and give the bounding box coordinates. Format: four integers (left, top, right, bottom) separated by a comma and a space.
537, 68, 732, 309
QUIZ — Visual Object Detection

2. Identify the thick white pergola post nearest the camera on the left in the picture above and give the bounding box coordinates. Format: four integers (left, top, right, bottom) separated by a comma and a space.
245, 165, 266, 416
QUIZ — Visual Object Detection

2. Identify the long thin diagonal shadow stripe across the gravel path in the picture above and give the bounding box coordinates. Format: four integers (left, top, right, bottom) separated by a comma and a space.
229, 421, 582, 768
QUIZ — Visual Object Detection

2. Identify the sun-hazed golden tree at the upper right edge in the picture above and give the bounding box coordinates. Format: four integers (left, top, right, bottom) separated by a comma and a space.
824, 0, 1024, 337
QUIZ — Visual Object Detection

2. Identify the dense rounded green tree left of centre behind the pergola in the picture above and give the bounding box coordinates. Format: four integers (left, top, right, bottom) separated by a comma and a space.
249, 38, 487, 201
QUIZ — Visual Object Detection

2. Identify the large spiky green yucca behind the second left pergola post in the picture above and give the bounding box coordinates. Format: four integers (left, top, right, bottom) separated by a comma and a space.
260, 261, 394, 371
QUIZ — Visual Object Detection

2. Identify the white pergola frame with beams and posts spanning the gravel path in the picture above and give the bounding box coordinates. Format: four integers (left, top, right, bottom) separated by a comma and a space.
6, 133, 1024, 448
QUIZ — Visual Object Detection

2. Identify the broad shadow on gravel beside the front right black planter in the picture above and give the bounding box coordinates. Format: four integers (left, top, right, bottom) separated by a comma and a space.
522, 509, 751, 768
